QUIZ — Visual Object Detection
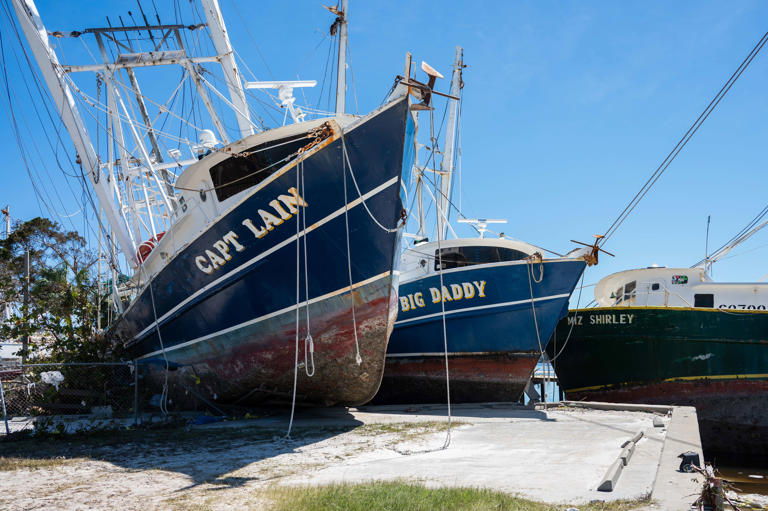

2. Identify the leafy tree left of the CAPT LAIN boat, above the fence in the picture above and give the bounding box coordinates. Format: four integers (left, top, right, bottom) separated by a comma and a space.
0, 218, 116, 362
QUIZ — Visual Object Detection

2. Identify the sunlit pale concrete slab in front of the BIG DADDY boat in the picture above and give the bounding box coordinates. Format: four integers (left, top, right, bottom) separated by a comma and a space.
281, 403, 695, 504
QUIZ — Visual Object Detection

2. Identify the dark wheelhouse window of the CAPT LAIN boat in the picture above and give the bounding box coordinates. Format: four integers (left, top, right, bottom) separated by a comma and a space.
210, 133, 307, 201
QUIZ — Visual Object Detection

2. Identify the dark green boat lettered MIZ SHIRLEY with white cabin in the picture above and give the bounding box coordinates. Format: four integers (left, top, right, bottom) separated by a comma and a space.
548, 266, 768, 462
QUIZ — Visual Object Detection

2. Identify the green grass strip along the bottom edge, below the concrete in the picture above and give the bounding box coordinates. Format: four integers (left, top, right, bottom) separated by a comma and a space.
270, 482, 647, 511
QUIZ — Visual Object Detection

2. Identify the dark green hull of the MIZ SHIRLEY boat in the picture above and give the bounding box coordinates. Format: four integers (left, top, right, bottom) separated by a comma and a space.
548, 307, 768, 463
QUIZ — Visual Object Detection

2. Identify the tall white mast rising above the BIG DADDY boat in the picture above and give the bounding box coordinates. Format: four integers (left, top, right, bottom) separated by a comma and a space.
436, 46, 464, 239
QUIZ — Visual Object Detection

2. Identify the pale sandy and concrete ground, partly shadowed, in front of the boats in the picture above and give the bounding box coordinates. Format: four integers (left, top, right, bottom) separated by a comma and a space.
0, 406, 680, 510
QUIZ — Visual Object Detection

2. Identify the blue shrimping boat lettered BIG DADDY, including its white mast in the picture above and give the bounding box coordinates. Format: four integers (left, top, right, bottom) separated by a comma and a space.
376, 48, 589, 403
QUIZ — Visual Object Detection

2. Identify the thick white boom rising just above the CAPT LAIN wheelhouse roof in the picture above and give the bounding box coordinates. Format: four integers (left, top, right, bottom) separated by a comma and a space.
201, 0, 254, 138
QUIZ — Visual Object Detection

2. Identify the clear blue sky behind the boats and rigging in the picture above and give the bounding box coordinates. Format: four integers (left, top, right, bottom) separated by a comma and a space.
0, 0, 768, 292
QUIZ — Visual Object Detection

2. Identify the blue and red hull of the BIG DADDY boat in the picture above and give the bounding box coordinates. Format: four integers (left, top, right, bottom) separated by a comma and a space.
375, 259, 585, 403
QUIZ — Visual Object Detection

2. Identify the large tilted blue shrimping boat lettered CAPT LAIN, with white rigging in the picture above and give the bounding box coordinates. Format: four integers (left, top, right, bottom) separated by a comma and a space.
12, 0, 420, 405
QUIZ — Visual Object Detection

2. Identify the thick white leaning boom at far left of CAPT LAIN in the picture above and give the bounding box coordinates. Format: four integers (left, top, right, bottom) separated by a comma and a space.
11, 0, 136, 265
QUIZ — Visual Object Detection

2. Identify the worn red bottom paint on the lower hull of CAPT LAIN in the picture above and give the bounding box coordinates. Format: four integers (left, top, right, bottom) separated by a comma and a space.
142, 279, 397, 406
